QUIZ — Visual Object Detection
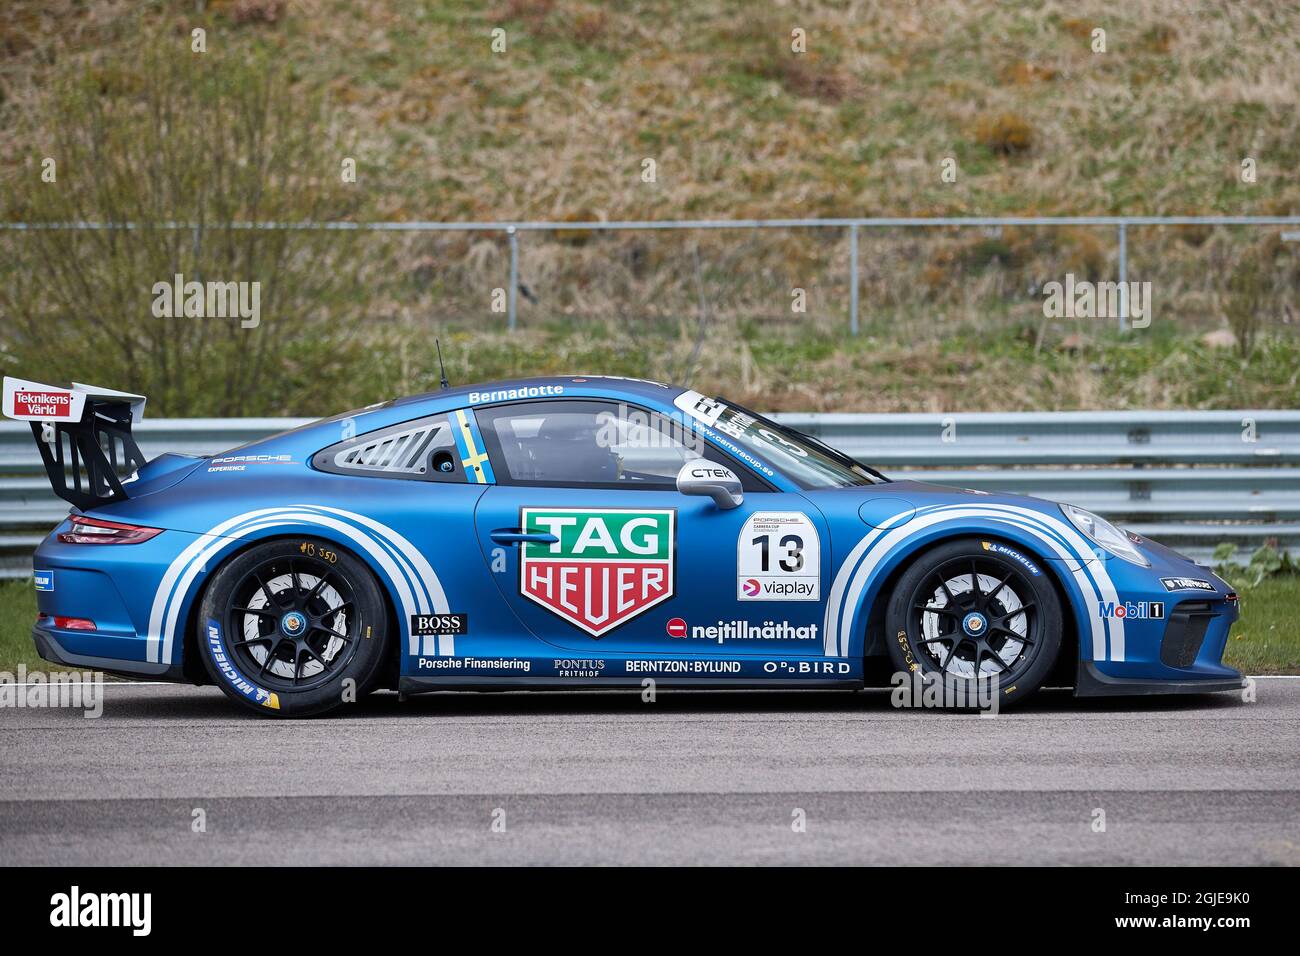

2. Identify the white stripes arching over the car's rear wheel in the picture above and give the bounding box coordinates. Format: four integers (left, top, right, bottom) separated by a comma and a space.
146, 505, 449, 662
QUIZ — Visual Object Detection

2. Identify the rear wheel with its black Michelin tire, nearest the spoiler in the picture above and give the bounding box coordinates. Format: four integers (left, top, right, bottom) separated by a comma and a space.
198, 538, 387, 717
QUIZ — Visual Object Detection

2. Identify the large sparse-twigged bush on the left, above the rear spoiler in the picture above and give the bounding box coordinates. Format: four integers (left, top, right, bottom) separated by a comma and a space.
0, 21, 360, 415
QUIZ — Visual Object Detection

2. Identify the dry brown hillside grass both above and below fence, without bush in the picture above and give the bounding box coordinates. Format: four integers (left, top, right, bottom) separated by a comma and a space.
0, 0, 1300, 407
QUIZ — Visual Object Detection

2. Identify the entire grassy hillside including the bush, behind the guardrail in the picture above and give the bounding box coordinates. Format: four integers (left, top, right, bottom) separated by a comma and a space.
0, 0, 1300, 415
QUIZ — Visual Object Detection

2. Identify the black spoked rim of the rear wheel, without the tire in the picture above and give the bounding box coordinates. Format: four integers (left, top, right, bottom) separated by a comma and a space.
228, 557, 361, 691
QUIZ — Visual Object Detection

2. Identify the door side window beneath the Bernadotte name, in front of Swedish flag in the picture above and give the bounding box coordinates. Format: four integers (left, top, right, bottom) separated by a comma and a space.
476, 399, 763, 490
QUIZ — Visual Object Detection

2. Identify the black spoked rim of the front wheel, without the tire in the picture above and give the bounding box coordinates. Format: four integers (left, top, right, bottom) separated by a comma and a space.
909, 555, 1041, 683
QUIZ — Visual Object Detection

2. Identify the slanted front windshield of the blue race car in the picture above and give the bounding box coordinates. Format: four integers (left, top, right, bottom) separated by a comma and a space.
712, 397, 888, 488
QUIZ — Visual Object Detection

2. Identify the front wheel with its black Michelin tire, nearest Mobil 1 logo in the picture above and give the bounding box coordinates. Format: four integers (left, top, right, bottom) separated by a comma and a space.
885, 538, 1063, 709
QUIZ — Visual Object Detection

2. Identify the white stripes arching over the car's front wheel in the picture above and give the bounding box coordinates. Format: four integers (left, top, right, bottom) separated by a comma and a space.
824, 503, 1125, 661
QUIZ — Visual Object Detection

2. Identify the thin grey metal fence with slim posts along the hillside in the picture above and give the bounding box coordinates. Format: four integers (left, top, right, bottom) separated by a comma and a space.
0, 216, 1300, 336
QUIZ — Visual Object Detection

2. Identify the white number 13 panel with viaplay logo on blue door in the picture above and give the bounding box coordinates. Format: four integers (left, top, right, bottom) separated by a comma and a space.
736, 511, 822, 601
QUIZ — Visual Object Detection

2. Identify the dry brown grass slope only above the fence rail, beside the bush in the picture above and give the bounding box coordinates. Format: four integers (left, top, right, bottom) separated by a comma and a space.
0, 0, 1300, 219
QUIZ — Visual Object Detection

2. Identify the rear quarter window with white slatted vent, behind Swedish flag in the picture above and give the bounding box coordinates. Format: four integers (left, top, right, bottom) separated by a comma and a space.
312, 415, 467, 481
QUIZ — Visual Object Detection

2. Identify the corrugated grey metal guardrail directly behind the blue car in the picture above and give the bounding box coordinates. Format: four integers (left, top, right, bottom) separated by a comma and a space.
0, 411, 1300, 578
